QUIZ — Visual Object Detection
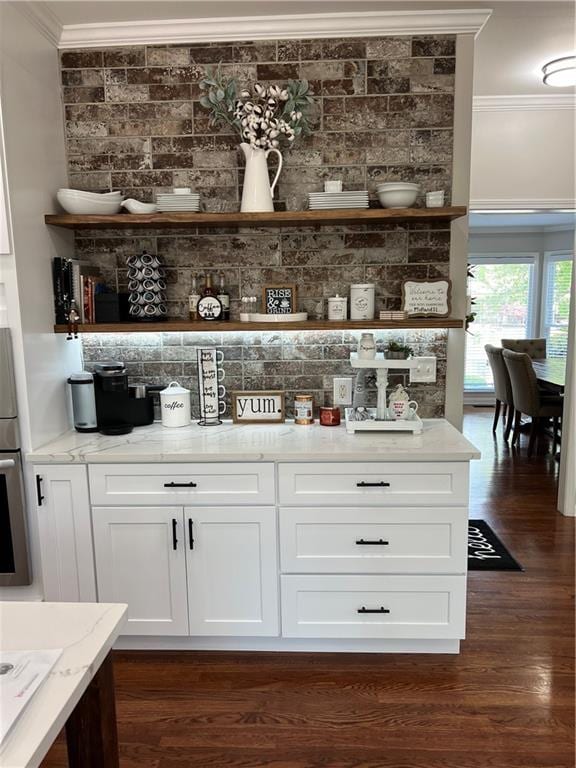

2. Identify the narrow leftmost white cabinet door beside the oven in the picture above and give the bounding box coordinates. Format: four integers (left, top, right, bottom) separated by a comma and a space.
34, 464, 96, 603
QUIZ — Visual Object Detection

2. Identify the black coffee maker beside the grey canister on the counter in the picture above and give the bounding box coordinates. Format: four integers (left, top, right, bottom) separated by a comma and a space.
94, 361, 134, 435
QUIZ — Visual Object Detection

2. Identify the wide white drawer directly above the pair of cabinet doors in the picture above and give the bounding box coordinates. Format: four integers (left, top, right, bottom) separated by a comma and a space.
89, 462, 275, 505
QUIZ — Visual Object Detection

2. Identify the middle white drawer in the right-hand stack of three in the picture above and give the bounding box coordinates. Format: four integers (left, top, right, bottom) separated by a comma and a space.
280, 507, 468, 573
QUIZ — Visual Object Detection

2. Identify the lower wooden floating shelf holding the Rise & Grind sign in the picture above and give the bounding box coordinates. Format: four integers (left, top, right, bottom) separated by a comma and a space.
54, 317, 464, 333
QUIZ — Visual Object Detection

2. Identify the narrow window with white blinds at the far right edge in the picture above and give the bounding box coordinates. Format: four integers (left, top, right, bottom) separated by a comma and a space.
542, 254, 573, 357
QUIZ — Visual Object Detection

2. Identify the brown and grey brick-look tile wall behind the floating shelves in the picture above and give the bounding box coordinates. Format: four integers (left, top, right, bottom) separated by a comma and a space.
61, 36, 455, 416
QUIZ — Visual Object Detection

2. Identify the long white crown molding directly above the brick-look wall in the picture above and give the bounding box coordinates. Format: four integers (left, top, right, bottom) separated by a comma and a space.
58, 9, 492, 49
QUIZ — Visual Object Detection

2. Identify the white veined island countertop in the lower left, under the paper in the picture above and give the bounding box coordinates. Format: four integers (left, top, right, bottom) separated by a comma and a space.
0, 602, 127, 768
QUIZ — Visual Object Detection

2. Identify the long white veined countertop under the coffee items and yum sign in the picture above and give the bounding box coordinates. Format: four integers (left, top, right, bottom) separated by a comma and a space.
26, 419, 480, 464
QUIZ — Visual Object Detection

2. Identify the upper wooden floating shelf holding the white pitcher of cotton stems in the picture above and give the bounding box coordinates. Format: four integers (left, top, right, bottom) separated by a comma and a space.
44, 206, 467, 229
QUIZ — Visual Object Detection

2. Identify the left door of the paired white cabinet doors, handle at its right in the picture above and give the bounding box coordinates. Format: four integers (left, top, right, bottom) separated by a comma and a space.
92, 507, 188, 635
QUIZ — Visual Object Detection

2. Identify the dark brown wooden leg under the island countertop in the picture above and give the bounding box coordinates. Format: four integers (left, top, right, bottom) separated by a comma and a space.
66, 653, 119, 768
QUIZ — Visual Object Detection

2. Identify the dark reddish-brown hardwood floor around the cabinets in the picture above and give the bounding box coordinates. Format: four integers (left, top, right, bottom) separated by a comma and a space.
43, 409, 574, 768
